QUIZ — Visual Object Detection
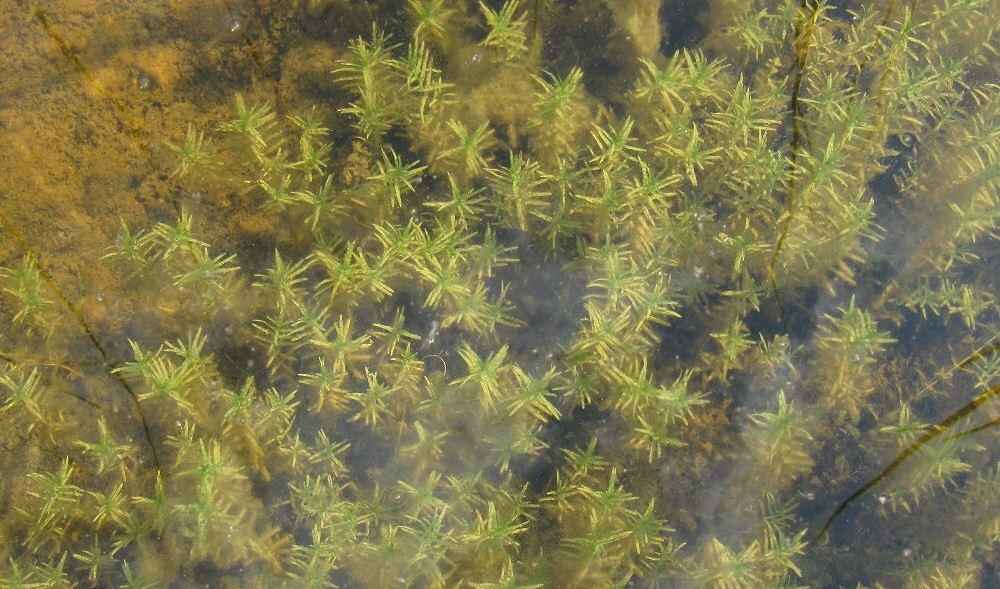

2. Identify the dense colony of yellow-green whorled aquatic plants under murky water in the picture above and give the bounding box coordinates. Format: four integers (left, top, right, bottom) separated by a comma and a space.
0, 0, 1000, 588
